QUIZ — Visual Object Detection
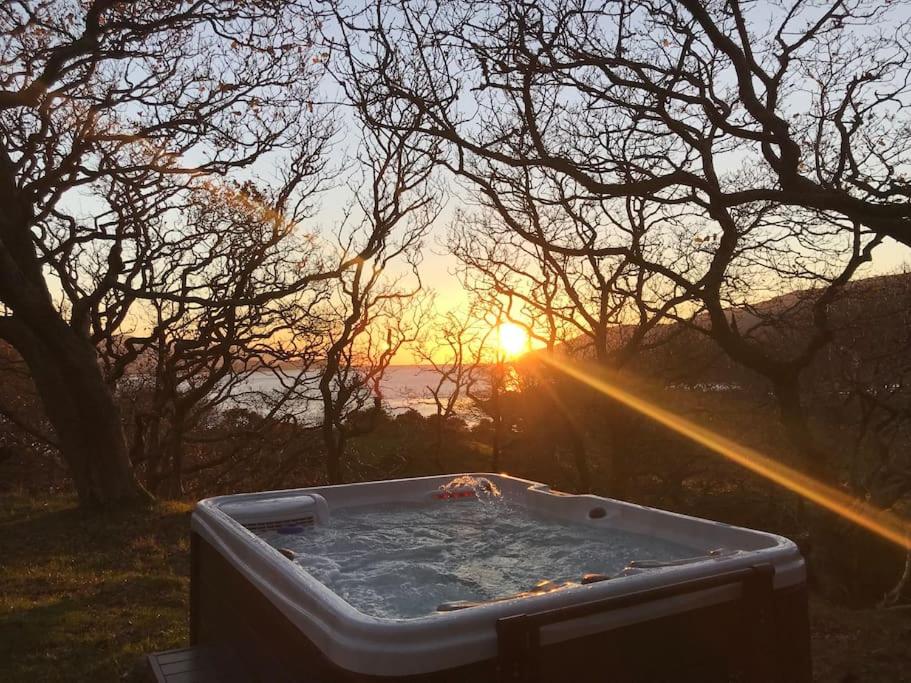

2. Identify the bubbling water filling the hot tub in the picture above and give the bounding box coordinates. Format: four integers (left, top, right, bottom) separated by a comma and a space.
261, 492, 702, 619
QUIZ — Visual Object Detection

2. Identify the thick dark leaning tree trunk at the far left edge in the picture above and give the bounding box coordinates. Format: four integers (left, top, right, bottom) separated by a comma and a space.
0, 155, 149, 507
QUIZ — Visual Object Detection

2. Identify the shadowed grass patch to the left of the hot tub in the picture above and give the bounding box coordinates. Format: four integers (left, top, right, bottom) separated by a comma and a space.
0, 497, 189, 681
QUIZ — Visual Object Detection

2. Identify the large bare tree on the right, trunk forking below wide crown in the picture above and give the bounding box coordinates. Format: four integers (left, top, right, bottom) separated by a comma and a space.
337, 1, 896, 480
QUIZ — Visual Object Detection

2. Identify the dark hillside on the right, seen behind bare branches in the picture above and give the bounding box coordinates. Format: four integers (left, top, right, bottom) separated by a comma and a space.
548, 273, 911, 391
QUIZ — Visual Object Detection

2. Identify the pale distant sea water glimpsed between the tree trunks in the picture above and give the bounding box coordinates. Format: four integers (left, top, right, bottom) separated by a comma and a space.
235, 365, 471, 417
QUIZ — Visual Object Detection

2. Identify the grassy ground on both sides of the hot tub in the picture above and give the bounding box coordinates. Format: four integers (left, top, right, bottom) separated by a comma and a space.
0, 495, 911, 683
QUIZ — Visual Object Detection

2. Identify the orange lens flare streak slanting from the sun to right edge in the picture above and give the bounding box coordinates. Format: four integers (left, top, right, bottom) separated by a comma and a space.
541, 354, 911, 550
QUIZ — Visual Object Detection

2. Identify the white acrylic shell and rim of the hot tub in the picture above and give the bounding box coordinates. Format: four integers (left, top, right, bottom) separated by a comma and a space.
192, 474, 806, 676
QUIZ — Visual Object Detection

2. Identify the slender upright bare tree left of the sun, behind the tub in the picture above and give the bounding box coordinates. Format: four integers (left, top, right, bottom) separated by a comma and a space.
318, 128, 440, 484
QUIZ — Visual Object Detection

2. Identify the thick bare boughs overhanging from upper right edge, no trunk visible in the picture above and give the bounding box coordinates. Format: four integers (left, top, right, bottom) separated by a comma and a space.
335, 0, 911, 245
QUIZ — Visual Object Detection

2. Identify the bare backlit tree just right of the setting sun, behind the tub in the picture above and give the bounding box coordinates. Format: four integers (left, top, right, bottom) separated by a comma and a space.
449, 183, 693, 496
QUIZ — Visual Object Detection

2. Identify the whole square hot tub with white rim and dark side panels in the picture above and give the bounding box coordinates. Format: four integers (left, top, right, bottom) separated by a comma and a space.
191, 474, 810, 682
